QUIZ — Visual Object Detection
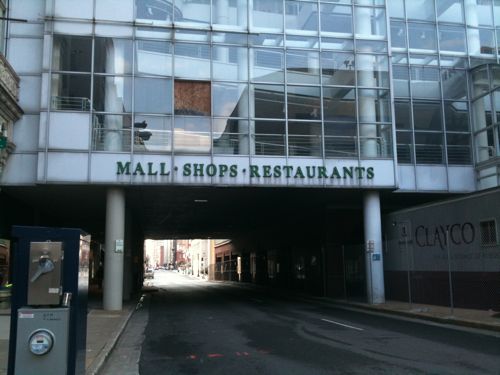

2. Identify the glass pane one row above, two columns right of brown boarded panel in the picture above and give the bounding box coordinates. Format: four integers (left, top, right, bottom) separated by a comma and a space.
250, 49, 285, 82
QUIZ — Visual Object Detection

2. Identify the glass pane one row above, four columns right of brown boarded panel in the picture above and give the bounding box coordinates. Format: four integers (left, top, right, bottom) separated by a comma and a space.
321, 52, 355, 86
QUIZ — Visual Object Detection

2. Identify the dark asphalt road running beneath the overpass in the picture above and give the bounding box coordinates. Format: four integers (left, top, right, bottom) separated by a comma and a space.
135, 271, 500, 375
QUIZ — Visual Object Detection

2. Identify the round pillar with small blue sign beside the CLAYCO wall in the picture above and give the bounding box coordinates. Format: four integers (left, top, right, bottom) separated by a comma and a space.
363, 191, 385, 304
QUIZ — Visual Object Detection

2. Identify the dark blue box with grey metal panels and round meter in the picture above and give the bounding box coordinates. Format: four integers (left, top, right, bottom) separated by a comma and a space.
7, 226, 90, 375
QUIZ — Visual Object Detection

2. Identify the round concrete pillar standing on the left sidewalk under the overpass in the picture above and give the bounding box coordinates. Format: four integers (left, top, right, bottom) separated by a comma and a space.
103, 188, 125, 310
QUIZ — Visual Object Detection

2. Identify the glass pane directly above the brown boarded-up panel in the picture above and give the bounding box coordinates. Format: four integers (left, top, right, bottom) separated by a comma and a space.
174, 43, 210, 79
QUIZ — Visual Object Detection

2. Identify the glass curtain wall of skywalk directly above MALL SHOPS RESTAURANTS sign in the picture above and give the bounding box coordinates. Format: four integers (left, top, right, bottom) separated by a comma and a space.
50, 0, 394, 159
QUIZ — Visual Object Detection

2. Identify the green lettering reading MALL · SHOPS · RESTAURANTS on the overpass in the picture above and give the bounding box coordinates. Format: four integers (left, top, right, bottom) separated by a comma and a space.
116, 161, 375, 180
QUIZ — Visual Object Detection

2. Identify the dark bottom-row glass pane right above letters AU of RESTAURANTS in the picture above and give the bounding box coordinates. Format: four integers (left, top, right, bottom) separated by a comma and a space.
288, 122, 321, 157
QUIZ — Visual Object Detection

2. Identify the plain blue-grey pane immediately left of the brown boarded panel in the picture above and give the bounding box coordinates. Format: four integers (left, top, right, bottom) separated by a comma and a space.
134, 77, 172, 113
